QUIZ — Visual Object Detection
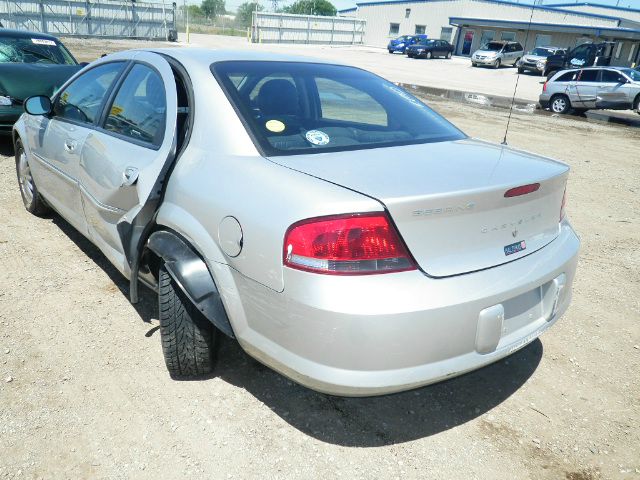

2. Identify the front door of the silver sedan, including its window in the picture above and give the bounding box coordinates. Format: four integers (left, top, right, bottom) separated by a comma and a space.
26, 62, 124, 235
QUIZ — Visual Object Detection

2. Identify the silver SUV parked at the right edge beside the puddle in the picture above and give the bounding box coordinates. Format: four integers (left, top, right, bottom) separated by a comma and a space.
539, 67, 640, 113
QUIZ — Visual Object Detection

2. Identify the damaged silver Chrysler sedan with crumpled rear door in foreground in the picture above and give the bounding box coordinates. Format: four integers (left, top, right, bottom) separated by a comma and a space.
14, 48, 579, 395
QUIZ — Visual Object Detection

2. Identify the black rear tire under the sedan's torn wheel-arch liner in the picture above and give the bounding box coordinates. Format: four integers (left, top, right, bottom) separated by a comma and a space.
158, 265, 218, 379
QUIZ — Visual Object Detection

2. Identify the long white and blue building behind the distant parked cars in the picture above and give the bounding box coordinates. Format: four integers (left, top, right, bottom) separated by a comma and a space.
339, 0, 640, 65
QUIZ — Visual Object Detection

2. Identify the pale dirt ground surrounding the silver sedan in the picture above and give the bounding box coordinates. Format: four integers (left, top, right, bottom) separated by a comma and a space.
0, 36, 640, 480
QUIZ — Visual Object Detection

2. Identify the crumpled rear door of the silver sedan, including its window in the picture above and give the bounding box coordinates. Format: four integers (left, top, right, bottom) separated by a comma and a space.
79, 52, 178, 274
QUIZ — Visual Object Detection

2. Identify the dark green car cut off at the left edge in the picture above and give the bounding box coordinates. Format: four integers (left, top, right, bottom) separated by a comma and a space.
0, 28, 82, 135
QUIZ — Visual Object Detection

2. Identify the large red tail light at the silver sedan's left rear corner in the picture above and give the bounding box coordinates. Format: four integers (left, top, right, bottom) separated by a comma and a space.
284, 213, 416, 275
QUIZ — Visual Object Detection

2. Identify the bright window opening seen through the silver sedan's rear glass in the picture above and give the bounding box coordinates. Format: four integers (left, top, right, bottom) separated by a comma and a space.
315, 77, 387, 126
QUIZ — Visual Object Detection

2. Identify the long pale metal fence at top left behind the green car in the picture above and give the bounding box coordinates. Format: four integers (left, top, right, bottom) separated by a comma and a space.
0, 0, 177, 41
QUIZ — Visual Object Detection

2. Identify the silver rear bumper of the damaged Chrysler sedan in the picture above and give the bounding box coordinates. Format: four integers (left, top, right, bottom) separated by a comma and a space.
230, 221, 580, 396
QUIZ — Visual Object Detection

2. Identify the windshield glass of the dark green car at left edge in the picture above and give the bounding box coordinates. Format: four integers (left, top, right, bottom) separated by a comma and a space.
0, 38, 77, 65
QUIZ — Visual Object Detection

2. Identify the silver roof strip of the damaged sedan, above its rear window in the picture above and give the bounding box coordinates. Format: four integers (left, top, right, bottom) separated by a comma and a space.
144, 47, 344, 65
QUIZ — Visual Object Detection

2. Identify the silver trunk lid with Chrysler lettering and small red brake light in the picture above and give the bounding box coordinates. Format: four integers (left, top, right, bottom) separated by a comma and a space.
270, 139, 568, 277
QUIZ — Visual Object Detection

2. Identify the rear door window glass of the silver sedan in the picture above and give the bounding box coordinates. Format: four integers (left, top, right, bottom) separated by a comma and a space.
104, 64, 167, 145
